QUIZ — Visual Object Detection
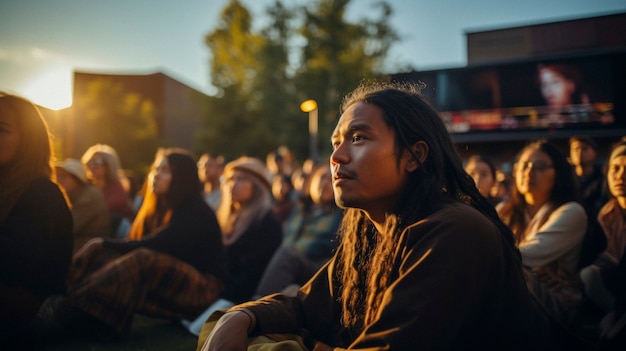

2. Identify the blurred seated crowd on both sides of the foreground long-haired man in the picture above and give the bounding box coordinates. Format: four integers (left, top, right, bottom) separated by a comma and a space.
0, 89, 626, 349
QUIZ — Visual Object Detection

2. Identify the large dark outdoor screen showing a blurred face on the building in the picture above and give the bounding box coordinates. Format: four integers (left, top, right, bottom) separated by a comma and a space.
392, 56, 616, 133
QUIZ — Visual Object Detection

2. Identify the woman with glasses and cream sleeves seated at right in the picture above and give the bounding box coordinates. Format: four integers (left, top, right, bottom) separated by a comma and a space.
497, 140, 587, 330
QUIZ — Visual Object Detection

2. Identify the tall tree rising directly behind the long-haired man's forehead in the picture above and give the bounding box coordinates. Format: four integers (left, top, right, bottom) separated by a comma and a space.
295, 0, 399, 157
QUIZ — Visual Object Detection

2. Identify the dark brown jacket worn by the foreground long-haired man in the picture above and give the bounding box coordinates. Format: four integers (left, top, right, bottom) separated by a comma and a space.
235, 203, 535, 350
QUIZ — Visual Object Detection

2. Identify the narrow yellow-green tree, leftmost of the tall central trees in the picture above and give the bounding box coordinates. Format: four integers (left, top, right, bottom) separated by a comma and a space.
200, 0, 272, 157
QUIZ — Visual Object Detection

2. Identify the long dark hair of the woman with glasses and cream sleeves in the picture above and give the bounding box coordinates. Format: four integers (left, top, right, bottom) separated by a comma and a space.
500, 139, 578, 242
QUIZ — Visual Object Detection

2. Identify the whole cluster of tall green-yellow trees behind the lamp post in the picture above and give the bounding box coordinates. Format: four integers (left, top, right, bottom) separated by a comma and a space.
198, 0, 399, 159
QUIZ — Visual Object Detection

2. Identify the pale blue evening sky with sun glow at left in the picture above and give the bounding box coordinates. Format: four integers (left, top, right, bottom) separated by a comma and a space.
0, 0, 626, 109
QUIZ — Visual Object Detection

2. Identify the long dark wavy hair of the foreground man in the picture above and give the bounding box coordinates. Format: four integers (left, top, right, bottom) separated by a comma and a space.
338, 82, 520, 327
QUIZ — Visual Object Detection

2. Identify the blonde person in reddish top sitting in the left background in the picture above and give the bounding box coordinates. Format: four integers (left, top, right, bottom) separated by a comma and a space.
81, 144, 133, 236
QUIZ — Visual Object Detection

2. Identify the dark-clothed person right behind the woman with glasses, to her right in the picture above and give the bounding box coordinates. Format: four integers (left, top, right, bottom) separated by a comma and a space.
568, 135, 608, 268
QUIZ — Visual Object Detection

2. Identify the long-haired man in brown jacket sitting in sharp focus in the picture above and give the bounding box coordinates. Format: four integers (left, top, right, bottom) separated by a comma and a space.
198, 83, 536, 351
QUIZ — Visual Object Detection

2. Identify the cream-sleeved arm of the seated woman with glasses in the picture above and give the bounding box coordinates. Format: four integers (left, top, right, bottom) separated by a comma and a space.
520, 202, 587, 267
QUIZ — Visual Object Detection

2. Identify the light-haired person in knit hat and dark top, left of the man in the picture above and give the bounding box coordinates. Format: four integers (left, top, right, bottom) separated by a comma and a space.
217, 156, 283, 303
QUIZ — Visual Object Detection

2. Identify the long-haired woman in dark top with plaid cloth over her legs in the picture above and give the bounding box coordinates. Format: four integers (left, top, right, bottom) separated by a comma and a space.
53, 148, 227, 340
